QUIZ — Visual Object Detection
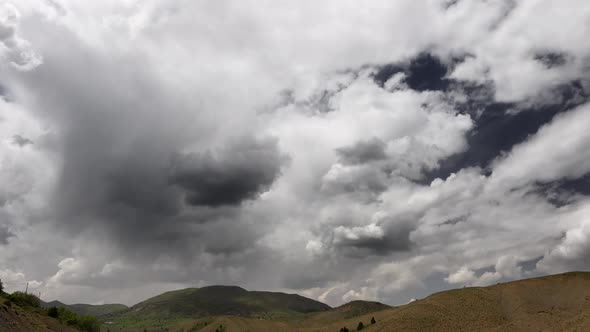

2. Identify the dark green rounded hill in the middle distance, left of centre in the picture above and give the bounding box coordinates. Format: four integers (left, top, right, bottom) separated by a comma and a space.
102, 286, 331, 331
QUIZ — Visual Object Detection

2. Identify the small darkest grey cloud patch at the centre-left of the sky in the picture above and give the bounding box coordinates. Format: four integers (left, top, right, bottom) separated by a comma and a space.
169, 139, 282, 207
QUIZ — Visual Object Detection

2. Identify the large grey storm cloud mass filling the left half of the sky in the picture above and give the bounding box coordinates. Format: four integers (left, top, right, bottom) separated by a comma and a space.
4, 27, 284, 261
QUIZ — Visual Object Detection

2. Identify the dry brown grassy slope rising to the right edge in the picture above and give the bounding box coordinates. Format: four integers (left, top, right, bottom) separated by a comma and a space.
366, 272, 590, 331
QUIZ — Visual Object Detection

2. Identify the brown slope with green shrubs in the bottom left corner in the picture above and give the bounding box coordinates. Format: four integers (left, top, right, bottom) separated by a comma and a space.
0, 298, 76, 332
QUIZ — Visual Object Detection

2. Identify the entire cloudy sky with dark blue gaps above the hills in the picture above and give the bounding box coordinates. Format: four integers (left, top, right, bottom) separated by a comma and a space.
0, 0, 590, 305
